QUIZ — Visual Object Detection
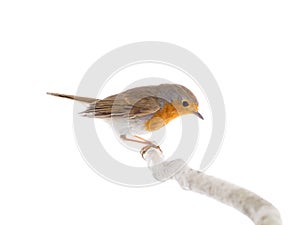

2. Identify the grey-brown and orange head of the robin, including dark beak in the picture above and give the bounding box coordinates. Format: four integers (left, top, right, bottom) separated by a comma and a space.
159, 84, 203, 119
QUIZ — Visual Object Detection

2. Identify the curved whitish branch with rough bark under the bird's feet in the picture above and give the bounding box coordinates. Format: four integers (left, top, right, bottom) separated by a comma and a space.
145, 149, 282, 225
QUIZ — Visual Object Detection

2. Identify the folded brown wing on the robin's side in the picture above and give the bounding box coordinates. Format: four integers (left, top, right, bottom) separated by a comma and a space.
82, 95, 160, 119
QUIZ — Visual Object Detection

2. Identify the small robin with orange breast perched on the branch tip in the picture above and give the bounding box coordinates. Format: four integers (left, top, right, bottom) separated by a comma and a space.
47, 83, 204, 157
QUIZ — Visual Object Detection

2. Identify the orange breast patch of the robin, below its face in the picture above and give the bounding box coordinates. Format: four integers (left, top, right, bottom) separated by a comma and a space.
145, 103, 179, 131
